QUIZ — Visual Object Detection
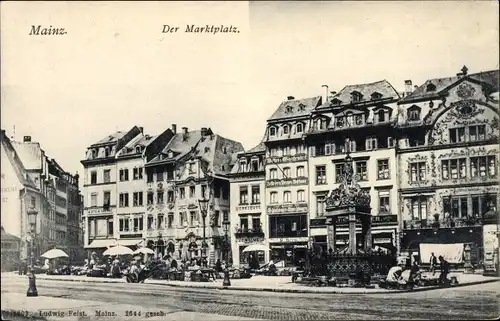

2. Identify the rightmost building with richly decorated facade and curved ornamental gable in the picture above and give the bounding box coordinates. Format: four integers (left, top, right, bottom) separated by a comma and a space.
397, 66, 499, 263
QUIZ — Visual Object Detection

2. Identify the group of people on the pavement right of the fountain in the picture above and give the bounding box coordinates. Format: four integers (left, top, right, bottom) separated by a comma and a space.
386, 252, 450, 285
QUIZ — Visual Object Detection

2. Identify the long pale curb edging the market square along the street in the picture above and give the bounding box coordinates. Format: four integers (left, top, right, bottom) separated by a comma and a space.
26, 277, 500, 294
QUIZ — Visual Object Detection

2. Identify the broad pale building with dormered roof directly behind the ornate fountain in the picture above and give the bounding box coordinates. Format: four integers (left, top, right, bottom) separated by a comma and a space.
305, 80, 400, 251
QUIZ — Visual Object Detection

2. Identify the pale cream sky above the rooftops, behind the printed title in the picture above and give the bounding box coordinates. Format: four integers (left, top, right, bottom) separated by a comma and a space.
0, 1, 499, 180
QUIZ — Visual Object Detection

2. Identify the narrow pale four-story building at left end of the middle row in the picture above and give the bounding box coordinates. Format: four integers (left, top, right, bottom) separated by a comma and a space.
81, 126, 141, 253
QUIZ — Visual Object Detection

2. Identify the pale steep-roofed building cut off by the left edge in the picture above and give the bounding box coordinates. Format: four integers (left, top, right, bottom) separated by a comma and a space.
0, 130, 45, 265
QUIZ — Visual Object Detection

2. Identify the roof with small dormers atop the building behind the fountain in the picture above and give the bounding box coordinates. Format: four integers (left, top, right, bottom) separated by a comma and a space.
319, 79, 400, 108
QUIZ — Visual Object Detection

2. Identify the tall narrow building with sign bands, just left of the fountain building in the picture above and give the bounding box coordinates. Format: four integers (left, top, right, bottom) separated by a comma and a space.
264, 96, 322, 265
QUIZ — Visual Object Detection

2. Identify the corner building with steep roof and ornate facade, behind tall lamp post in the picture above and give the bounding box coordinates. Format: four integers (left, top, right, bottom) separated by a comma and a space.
145, 125, 243, 262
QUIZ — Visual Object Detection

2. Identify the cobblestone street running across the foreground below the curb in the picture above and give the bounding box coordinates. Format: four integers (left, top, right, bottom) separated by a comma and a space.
2, 277, 500, 320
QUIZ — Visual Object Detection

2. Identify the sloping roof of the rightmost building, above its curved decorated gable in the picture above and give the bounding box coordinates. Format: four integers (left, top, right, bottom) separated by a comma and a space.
400, 70, 499, 102
